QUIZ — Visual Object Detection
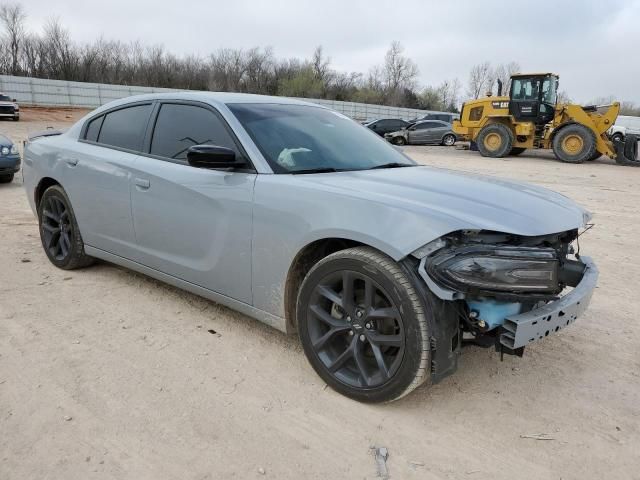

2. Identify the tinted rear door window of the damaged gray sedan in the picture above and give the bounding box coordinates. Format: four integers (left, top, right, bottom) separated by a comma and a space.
98, 105, 151, 150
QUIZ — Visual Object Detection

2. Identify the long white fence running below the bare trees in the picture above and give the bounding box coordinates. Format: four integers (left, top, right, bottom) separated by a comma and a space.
0, 75, 436, 120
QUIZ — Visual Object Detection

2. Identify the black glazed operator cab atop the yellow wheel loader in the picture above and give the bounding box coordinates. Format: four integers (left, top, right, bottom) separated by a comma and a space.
509, 73, 559, 125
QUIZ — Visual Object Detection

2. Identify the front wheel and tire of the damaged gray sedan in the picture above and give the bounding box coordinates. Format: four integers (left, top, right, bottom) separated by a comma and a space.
296, 247, 432, 403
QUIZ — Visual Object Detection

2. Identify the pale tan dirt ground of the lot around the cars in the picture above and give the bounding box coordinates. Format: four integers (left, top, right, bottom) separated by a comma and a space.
0, 110, 640, 480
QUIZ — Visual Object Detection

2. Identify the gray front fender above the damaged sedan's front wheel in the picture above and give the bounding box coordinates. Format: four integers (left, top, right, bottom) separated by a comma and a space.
252, 175, 462, 317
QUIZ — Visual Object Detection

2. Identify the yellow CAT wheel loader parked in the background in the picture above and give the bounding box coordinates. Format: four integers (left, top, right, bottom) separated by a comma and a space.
453, 73, 640, 167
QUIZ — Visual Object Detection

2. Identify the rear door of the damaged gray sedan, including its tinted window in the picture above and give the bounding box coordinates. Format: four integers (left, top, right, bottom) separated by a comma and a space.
65, 102, 152, 257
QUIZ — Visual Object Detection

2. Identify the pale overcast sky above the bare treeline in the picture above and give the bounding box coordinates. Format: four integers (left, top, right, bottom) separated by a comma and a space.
21, 0, 640, 104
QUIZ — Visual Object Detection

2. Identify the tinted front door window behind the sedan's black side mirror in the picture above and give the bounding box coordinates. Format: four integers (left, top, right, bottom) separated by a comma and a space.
151, 103, 238, 160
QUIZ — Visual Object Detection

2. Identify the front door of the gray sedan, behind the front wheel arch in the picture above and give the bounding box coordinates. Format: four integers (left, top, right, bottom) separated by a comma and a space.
131, 102, 256, 303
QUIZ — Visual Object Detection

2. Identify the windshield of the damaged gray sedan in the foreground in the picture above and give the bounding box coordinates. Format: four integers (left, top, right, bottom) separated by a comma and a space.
227, 103, 416, 173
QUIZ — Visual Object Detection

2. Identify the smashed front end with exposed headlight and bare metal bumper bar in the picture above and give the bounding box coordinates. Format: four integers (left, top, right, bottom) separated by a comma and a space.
412, 229, 598, 380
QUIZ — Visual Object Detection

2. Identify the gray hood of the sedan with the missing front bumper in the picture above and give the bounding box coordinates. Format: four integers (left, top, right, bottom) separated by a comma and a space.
299, 166, 591, 236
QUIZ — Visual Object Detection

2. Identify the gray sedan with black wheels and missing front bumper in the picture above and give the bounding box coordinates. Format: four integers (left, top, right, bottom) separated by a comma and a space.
24, 92, 597, 402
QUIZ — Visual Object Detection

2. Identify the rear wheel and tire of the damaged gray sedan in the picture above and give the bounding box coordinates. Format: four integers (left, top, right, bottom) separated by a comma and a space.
38, 185, 93, 270
